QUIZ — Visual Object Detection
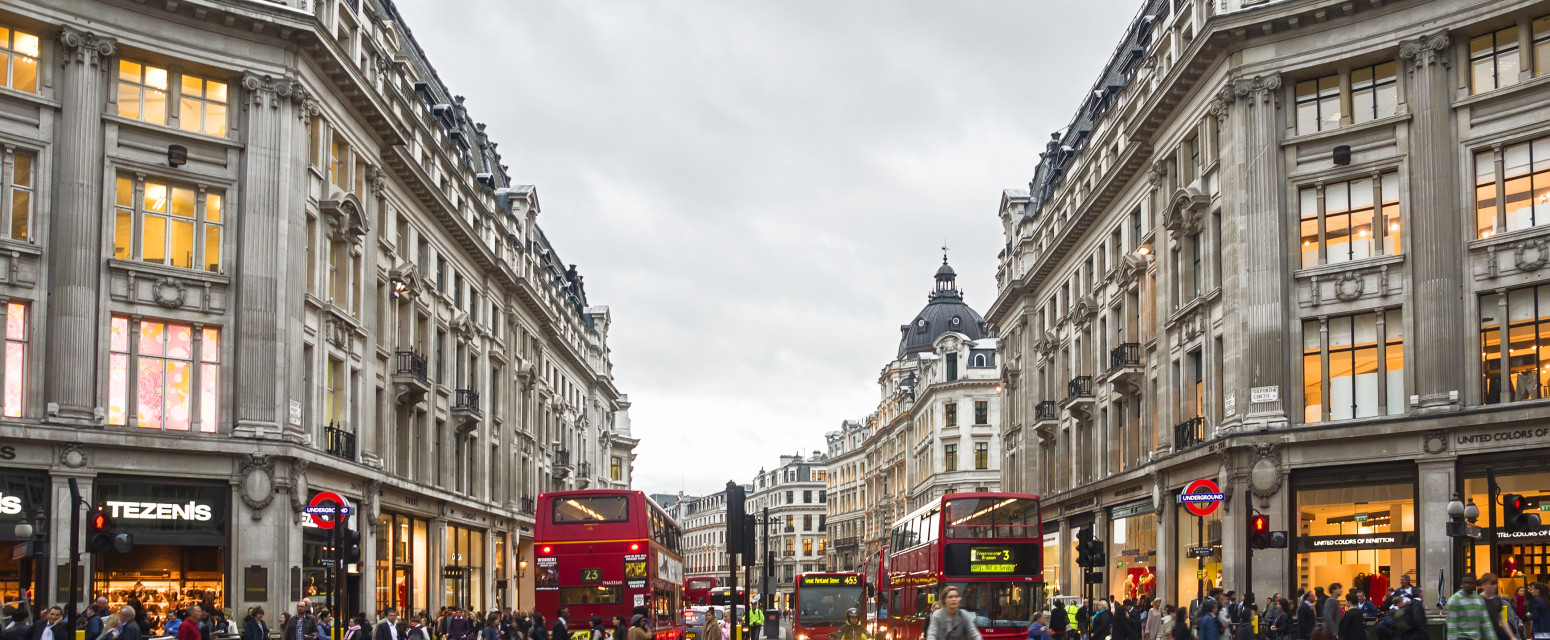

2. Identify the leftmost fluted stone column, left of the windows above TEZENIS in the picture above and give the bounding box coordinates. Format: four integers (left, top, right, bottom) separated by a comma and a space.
43, 26, 116, 425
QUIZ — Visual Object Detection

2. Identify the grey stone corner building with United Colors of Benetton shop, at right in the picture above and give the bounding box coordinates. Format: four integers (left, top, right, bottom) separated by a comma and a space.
987, 0, 1550, 603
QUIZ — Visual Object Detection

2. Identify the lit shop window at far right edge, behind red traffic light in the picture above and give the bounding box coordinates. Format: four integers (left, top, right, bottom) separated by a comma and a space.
1463, 471, 1550, 594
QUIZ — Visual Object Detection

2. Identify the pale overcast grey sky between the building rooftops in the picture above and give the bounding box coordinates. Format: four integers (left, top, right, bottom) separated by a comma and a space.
397, 0, 1141, 493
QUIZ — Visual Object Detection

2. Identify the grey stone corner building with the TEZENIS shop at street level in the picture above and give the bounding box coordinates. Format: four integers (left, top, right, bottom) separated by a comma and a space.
0, 0, 637, 615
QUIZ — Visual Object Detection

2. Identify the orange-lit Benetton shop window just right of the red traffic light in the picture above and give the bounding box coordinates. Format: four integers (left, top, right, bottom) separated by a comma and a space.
1296, 482, 1418, 594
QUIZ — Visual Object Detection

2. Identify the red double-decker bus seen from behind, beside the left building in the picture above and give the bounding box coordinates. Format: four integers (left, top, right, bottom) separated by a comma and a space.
533, 490, 684, 640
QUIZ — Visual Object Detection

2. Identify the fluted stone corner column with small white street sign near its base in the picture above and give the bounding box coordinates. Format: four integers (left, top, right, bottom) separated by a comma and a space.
1212, 73, 1291, 429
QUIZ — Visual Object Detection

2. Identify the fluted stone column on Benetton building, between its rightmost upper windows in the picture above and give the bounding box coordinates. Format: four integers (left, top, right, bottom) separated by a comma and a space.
1400, 31, 1469, 412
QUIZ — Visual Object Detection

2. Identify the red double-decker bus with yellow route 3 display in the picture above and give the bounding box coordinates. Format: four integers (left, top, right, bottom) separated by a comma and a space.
884, 493, 1043, 640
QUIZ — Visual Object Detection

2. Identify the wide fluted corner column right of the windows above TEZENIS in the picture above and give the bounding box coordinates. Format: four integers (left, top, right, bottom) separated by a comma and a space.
233, 74, 318, 442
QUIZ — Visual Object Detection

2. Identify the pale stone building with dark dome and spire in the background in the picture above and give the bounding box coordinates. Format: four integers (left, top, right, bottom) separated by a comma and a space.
826, 257, 1003, 570
